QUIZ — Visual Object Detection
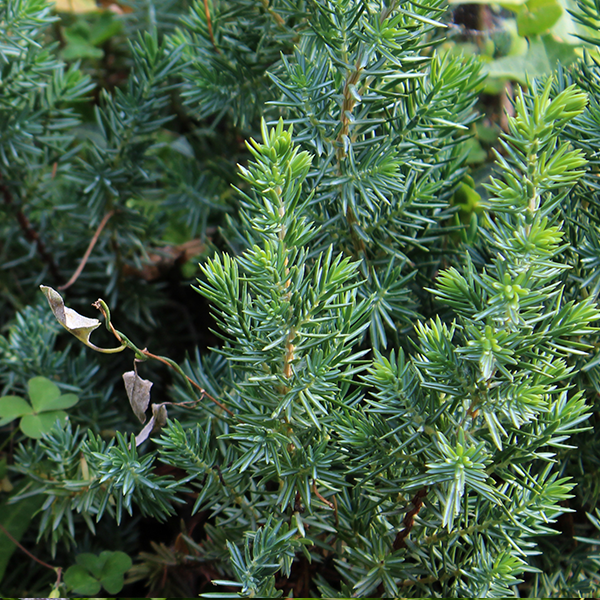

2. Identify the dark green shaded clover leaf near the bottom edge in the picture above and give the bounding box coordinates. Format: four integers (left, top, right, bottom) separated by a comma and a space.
65, 550, 132, 596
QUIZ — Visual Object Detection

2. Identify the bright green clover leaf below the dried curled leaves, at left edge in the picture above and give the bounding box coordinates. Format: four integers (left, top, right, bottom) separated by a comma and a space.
0, 377, 79, 438
